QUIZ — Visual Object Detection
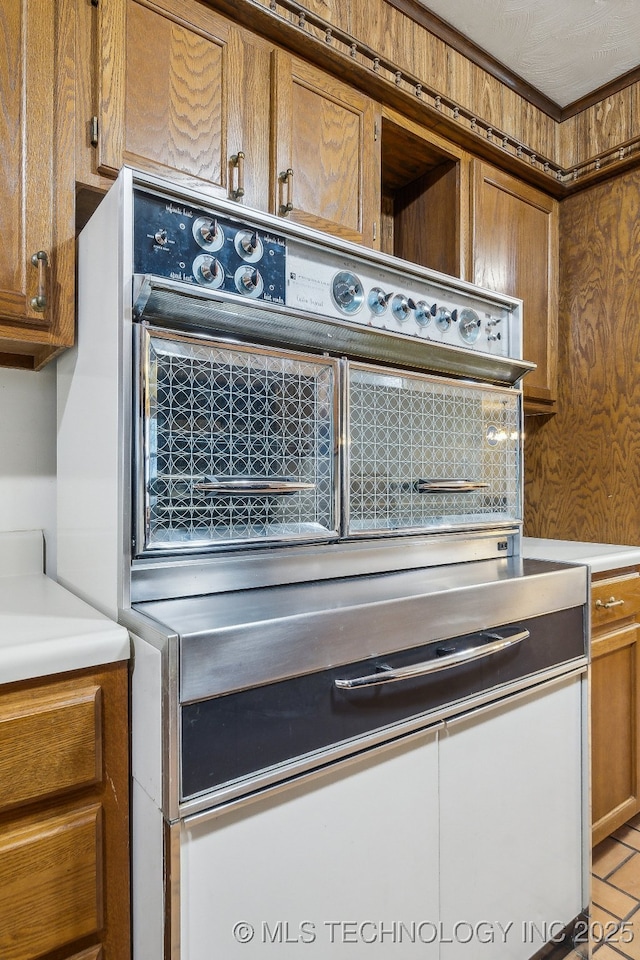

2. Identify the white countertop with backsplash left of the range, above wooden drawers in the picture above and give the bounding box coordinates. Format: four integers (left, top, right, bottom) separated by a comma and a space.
0, 530, 130, 684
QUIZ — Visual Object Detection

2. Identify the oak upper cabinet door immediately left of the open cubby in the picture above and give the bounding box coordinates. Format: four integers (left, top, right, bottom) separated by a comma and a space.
272, 51, 380, 246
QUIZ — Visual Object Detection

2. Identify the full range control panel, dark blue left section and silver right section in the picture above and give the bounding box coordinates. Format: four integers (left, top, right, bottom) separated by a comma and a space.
133, 189, 522, 359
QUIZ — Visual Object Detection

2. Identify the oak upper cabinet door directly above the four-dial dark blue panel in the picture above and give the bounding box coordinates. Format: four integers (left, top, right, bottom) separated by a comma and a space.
98, 0, 270, 208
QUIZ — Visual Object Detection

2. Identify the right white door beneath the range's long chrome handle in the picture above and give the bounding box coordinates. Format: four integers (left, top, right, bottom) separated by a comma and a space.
440, 677, 588, 960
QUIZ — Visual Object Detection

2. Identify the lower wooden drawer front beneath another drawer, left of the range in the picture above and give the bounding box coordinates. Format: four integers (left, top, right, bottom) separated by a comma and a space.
0, 804, 102, 960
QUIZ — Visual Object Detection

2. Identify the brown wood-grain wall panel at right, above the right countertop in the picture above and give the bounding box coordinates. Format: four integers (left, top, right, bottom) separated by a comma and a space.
525, 171, 640, 544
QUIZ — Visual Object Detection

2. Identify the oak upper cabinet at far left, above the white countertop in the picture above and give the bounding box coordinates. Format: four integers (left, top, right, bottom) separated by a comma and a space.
0, 0, 75, 369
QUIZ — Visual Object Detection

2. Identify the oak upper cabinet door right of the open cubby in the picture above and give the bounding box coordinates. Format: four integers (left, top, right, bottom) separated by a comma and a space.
472, 160, 559, 413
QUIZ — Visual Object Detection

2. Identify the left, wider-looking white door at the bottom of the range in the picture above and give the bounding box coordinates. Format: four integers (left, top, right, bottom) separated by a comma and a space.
180, 731, 439, 960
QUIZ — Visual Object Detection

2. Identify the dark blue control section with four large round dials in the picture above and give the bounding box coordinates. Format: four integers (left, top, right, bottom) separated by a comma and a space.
134, 190, 287, 304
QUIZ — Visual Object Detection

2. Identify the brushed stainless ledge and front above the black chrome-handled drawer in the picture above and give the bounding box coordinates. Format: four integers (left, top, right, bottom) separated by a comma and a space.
132, 557, 587, 702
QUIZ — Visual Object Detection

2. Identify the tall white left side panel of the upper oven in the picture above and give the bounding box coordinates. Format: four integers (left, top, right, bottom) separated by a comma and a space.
57, 181, 127, 619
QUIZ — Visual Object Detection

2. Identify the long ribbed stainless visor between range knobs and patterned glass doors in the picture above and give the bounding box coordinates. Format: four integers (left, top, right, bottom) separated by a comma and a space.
134, 276, 536, 385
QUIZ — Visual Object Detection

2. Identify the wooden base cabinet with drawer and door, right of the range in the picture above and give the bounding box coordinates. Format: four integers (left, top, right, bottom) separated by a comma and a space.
591, 570, 640, 845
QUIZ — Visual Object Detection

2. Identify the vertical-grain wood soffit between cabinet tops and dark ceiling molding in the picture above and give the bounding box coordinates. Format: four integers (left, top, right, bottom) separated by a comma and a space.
241, 0, 640, 186
